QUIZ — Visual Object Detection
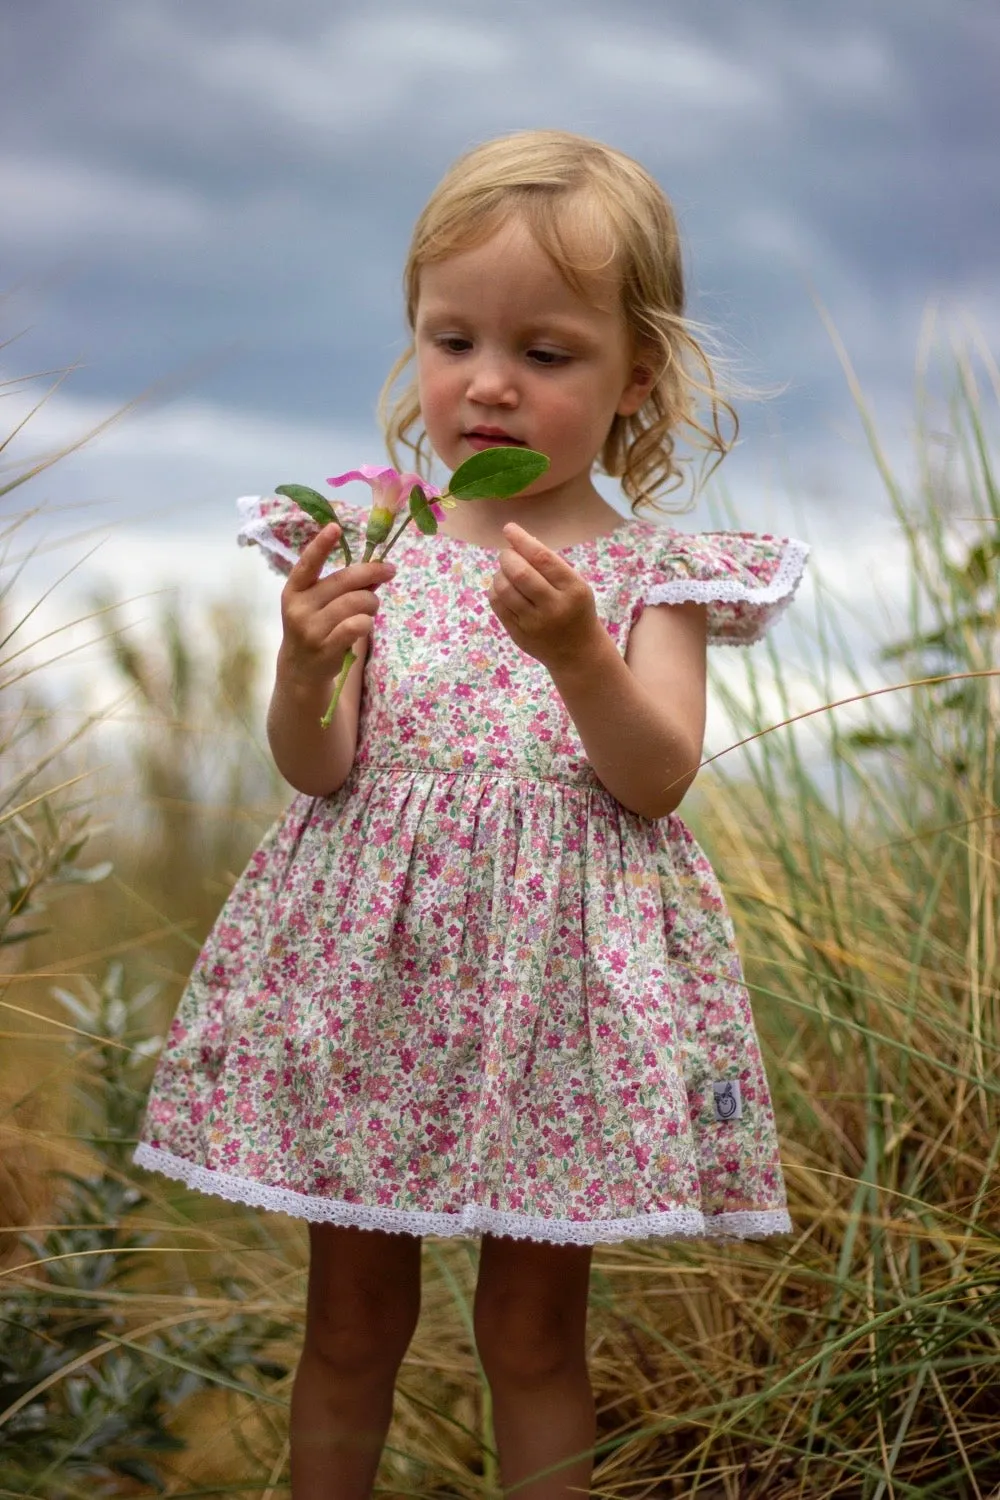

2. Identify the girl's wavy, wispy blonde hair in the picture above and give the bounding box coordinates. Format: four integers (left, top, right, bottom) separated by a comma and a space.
378, 131, 739, 512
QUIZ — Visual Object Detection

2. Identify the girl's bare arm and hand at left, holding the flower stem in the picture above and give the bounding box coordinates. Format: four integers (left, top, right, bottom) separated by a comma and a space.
267, 525, 396, 797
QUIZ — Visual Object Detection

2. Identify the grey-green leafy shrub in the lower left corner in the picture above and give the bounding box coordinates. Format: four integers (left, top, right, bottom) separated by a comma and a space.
0, 963, 285, 1500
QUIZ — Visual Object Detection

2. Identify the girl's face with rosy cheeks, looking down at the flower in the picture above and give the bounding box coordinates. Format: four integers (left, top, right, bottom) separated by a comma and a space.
415, 221, 651, 501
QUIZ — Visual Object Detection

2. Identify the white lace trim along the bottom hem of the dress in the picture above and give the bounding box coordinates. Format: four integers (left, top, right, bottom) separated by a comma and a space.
133, 1142, 792, 1245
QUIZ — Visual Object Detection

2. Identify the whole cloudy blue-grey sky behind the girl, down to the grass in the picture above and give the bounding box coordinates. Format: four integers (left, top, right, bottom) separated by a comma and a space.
0, 0, 1000, 762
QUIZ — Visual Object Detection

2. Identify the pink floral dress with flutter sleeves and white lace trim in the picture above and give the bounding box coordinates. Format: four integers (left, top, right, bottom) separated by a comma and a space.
135, 497, 808, 1244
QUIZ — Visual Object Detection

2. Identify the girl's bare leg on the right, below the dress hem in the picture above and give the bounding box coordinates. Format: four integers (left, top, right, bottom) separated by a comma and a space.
474, 1235, 597, 1500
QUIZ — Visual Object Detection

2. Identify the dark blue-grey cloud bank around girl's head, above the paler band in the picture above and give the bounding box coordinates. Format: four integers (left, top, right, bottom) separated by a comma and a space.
0, 0, 1000, 516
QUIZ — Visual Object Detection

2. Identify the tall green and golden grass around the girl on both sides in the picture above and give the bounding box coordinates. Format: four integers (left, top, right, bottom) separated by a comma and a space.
0, 322, 1000, 1500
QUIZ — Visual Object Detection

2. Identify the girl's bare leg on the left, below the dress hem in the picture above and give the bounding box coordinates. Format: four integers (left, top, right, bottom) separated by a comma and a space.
289, 1224, 421, 1500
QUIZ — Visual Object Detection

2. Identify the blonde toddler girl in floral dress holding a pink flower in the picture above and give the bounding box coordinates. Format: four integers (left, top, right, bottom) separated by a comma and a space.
135, 131, 808, 1500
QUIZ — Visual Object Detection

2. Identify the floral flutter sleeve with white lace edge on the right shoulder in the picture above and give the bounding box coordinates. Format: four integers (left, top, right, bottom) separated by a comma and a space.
643, 531, 810, 647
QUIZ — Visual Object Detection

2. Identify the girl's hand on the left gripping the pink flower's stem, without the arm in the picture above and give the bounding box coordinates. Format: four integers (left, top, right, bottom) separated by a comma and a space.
280, 522, 396, 683
